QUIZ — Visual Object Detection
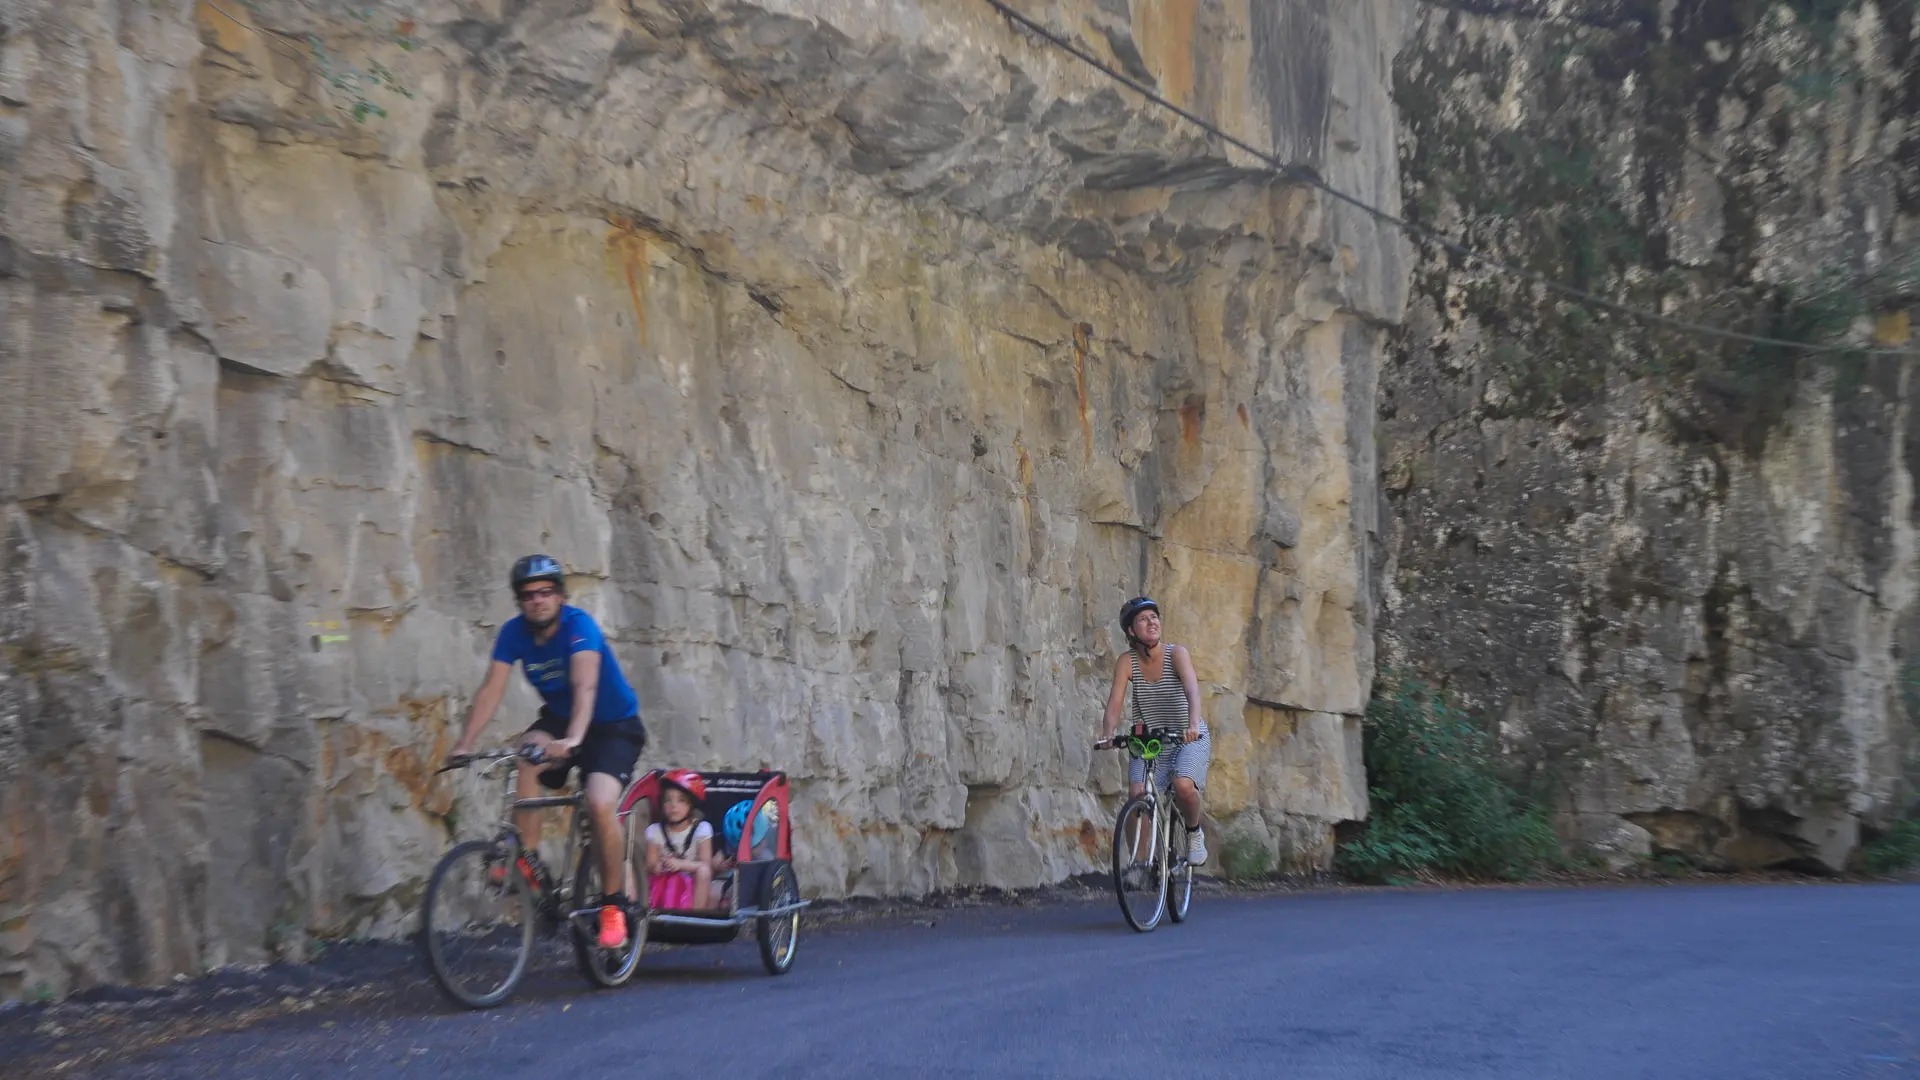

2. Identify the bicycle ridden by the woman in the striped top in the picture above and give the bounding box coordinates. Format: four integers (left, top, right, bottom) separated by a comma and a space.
1094, 724, 1194, 934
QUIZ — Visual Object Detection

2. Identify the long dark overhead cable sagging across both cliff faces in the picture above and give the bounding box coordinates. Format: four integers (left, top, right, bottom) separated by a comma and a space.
983, 0, 1916, 356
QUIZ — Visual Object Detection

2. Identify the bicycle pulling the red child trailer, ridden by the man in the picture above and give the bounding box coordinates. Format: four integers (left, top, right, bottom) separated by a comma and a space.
420, 746, 647, 1009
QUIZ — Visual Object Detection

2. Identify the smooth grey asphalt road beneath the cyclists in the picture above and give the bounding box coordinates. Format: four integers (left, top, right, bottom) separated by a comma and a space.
22, 886, 1920, 1080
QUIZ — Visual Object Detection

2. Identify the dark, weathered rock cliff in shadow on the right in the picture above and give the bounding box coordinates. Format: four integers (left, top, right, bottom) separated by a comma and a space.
1380, 0, 1920, 869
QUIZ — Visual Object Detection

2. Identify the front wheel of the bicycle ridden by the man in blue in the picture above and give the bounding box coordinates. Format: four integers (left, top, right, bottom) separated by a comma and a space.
420, 840, 534, 1009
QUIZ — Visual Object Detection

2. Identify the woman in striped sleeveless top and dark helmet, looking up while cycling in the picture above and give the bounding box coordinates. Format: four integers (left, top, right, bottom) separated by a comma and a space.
1100, 596, 1213, 867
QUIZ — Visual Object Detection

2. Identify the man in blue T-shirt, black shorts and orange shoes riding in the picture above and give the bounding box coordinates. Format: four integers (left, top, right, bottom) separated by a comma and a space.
447, 555, 647, 949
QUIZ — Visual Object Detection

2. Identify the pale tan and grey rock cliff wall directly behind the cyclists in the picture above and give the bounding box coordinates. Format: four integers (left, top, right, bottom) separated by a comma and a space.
0, 0, 1413, 995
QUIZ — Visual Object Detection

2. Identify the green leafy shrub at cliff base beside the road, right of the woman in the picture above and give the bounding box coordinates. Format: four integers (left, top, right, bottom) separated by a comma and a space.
1334, 680, 1563, 882
